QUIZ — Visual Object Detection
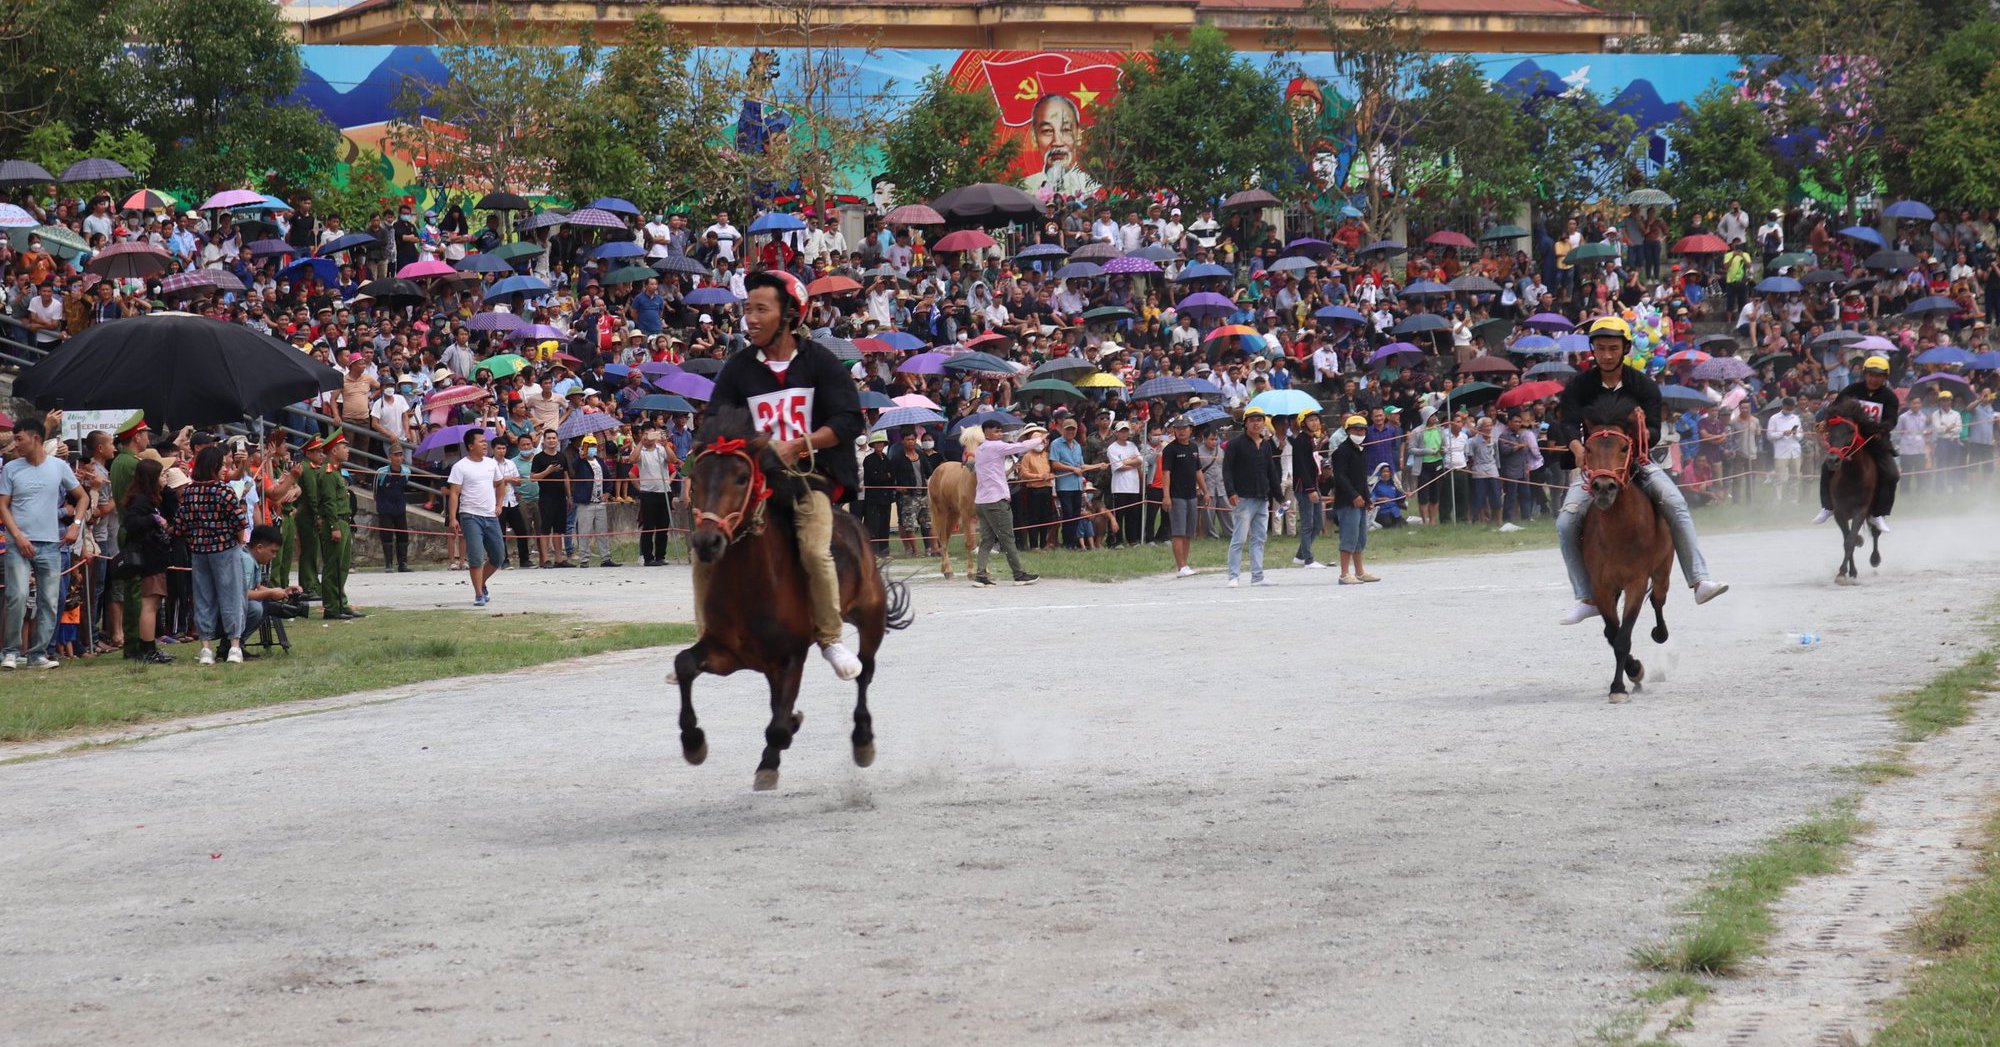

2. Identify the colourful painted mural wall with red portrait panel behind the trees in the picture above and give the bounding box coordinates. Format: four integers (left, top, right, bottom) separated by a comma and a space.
298, 46, 1742, 206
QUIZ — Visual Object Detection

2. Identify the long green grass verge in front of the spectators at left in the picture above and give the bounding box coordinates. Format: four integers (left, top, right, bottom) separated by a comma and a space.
0, 611, 694, 741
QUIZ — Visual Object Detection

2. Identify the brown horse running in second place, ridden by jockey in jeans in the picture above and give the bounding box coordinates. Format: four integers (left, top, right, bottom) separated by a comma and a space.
1578, 412, 1674, 703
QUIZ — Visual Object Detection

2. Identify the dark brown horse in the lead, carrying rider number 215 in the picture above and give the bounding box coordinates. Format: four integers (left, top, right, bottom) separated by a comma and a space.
670, 408, 912, 789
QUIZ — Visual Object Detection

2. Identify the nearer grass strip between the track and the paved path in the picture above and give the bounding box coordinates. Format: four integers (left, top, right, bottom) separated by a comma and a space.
1634, 797, 1860, 977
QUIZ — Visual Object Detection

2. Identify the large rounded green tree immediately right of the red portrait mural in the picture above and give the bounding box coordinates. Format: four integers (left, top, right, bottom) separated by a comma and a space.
1084, 26, 1292, 200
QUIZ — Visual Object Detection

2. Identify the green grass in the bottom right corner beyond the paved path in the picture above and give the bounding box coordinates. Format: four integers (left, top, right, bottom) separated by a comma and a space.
1874, 813, 2000, 1047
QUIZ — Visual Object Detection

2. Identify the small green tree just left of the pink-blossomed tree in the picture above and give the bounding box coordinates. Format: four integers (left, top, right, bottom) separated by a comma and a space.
1660, 86, 1784, 212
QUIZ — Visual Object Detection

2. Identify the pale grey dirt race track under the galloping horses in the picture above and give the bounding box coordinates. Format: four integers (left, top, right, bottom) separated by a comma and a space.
0, 520, 2000, 1047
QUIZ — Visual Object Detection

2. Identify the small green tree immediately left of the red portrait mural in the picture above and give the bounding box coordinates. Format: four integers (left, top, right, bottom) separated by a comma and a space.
884, 72, 1020, 200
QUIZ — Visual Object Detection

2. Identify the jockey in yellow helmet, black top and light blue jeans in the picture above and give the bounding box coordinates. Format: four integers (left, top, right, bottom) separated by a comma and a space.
1556, 316, 1730, 625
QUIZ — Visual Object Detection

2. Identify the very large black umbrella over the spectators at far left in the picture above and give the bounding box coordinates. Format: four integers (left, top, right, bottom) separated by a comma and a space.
14, 312, 340, 426
